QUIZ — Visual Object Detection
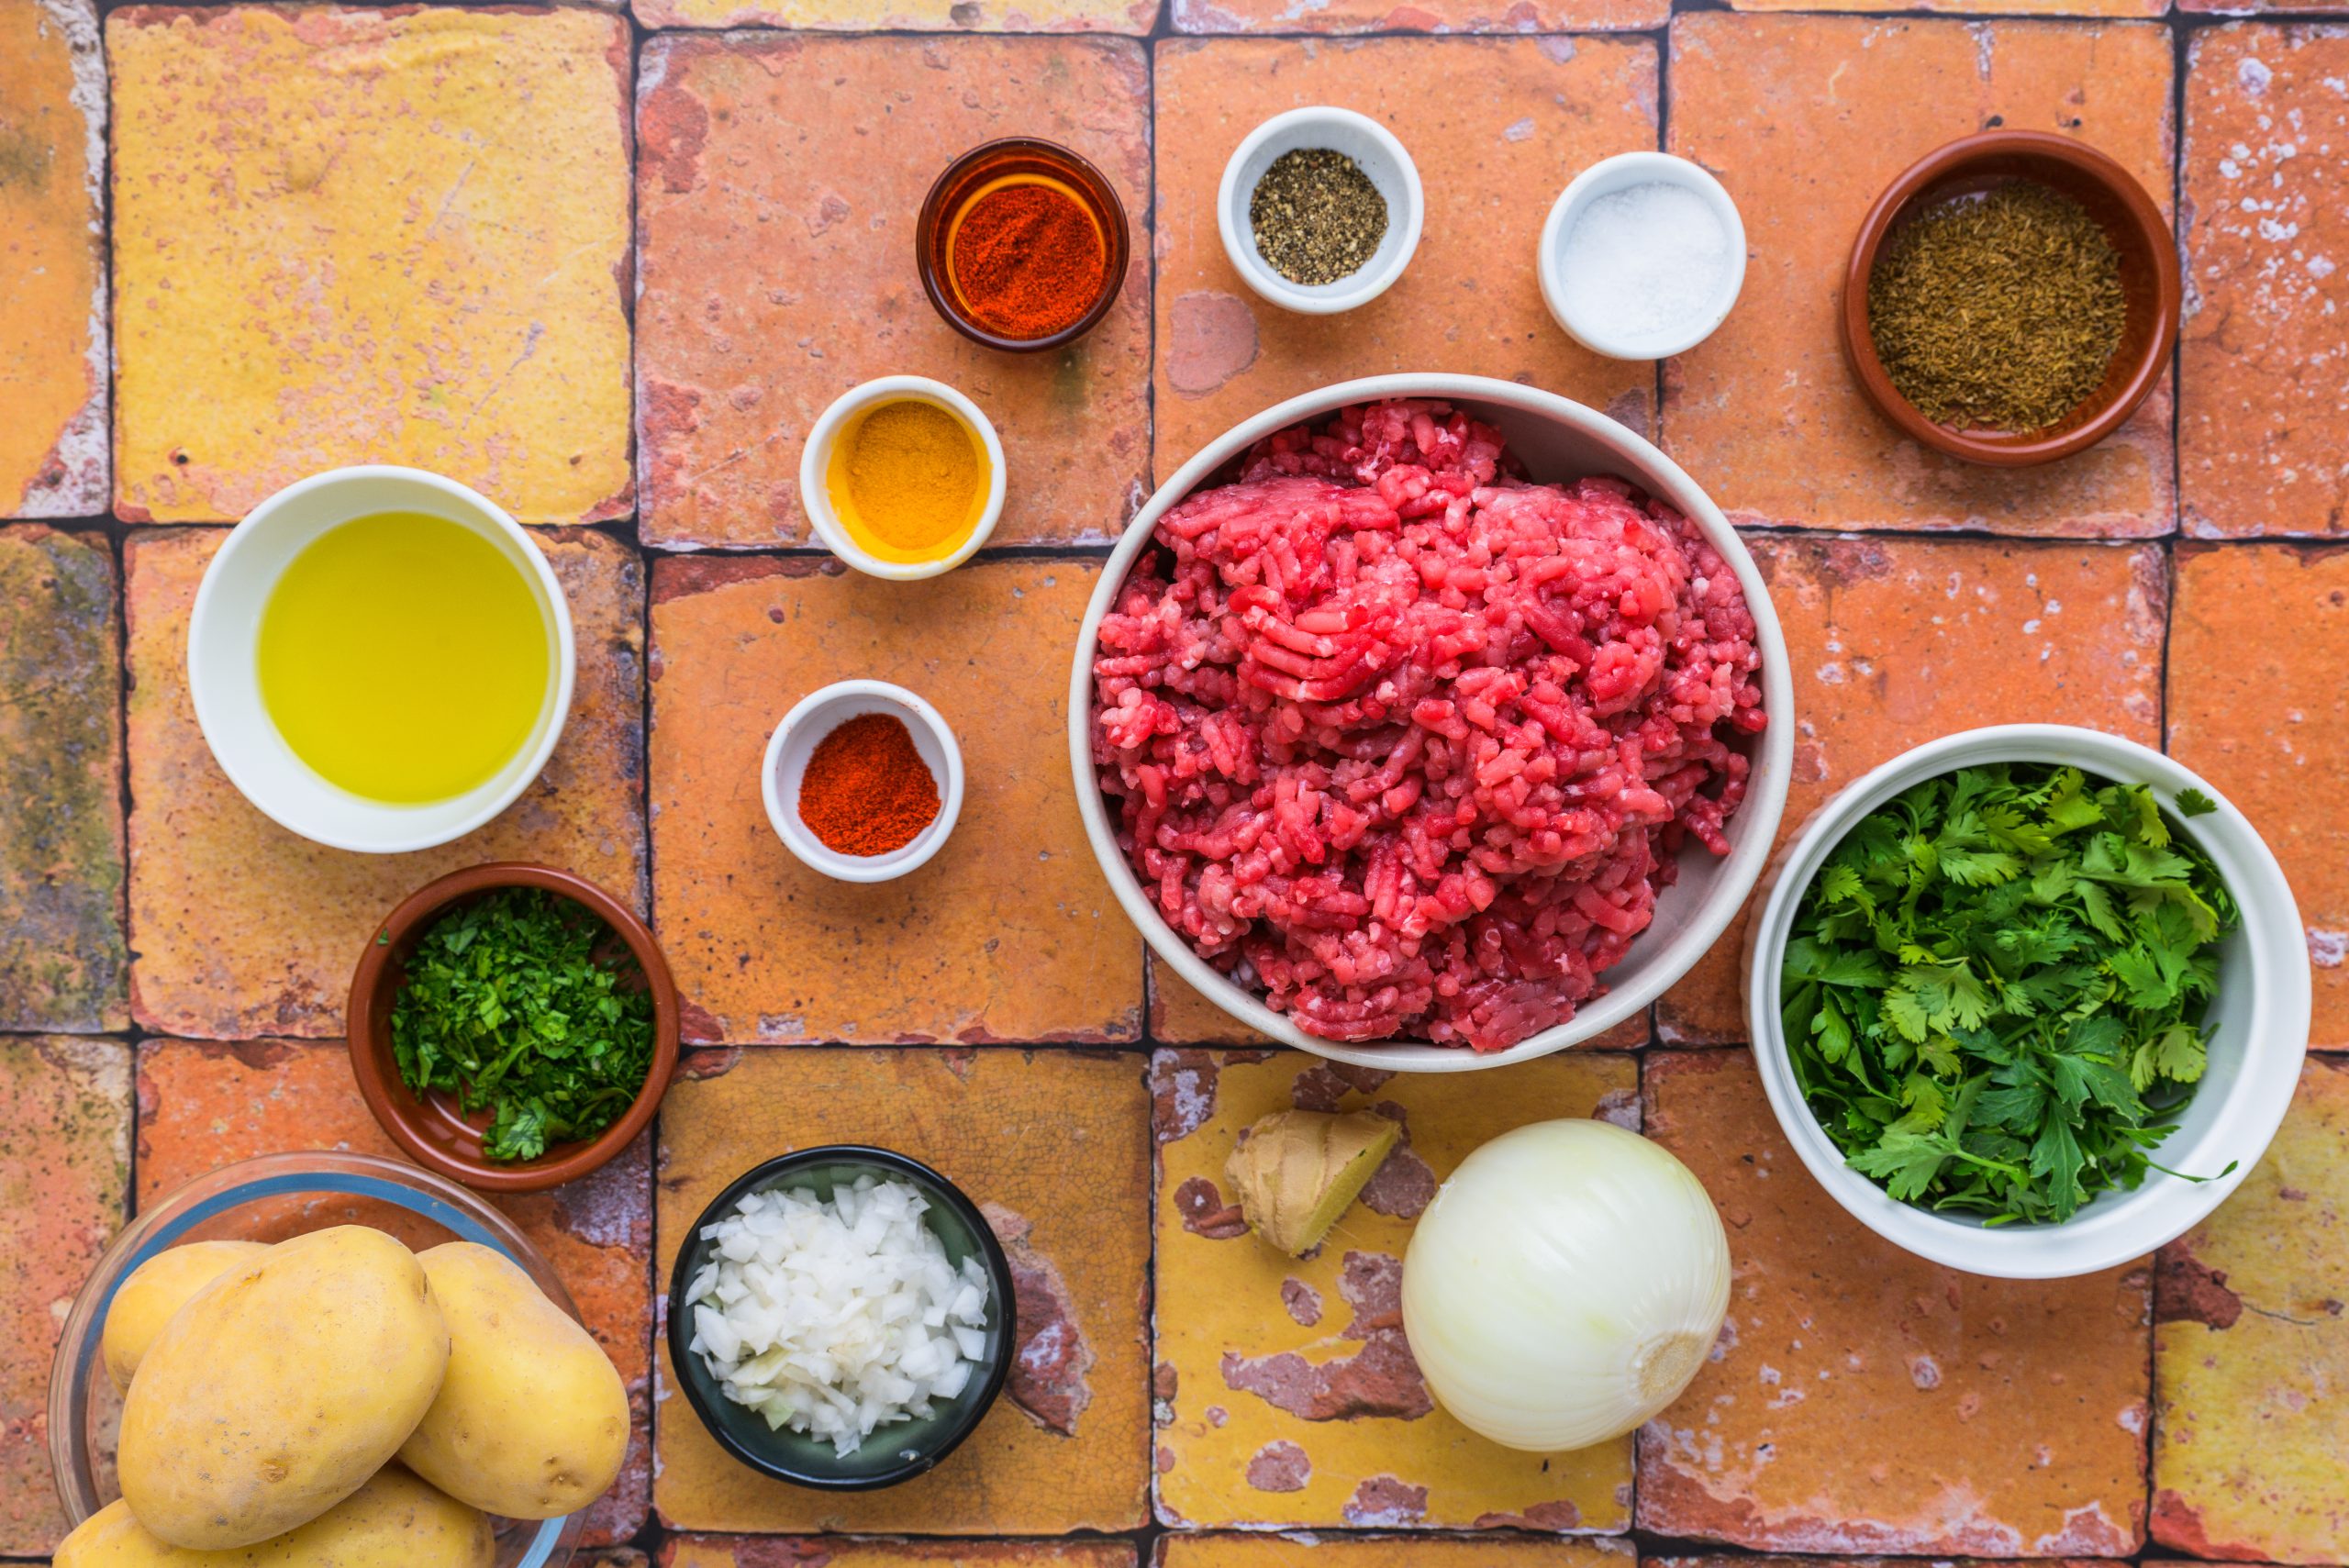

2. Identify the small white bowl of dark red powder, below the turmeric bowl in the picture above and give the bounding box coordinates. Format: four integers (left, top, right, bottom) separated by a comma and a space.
759, 681, 963, 883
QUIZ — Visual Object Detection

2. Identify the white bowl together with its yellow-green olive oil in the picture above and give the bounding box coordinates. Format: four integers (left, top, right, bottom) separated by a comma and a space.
188, 467, 575, 854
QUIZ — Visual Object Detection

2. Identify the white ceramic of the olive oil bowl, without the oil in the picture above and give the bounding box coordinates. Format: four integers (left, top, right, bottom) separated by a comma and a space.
188, 467, 578, 854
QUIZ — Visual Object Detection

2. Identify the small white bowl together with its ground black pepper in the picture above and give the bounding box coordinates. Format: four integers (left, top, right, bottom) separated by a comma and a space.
1215, 106, 1426, 315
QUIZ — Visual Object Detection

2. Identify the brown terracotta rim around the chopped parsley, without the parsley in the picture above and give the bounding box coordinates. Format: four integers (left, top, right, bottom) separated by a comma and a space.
343, 862, 681, 1193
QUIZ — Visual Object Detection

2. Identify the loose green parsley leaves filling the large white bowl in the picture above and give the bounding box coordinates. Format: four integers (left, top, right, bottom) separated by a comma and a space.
1780, 762, 2239, 1225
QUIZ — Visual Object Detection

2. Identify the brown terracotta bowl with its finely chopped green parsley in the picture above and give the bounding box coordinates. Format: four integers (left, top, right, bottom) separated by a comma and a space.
350, 862, 679, 1193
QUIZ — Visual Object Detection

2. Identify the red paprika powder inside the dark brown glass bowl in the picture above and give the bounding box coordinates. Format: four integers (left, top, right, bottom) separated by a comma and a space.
947, 181, 1108, 338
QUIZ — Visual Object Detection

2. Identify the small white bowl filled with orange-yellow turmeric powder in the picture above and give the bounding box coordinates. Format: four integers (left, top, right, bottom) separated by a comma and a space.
798, 375, 1003, 582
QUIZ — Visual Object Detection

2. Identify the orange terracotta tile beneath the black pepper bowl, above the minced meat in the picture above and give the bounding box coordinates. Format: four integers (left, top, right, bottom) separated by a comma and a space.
1156, 38, 1656, 474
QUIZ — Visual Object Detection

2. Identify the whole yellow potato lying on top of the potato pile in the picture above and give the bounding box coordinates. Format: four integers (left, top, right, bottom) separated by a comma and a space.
117, 1225, 449, 1551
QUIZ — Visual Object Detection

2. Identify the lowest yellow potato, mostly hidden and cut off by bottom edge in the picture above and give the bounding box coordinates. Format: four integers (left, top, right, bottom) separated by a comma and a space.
54, 1464, 498, 1568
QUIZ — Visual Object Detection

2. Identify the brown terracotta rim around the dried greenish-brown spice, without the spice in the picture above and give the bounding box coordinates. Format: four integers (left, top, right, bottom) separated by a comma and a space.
1837, 129, 2182, 467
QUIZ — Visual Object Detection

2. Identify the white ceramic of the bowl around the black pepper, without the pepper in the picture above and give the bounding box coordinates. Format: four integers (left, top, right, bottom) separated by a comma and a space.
1215, 108, 1426, 317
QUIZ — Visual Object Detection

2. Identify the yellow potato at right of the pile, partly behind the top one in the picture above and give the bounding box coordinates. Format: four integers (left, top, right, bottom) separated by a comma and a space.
399, 1241, 628, 1518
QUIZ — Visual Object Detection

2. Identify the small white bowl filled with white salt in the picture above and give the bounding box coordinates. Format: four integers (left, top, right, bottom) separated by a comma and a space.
1539, 152, 1745, 359
